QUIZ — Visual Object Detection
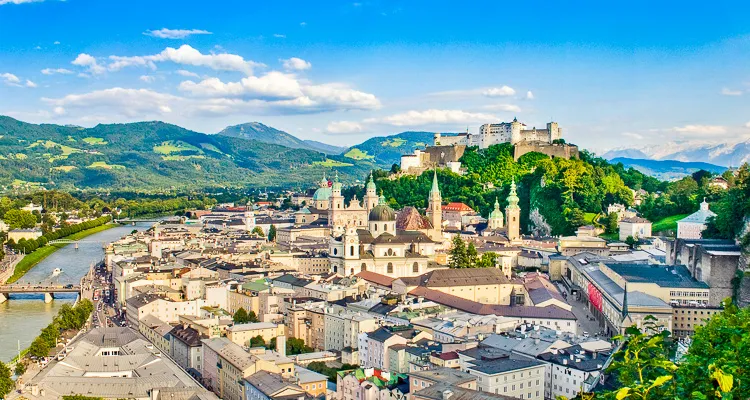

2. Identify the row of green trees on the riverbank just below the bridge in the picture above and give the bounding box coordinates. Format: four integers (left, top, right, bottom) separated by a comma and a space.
28, 299, 94, 358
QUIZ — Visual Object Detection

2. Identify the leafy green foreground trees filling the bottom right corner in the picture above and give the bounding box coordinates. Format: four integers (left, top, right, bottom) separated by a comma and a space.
579, 299, 750, 400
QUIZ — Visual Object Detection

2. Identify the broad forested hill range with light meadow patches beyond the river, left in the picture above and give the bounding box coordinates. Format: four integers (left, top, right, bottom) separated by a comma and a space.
0, 116, 374, 191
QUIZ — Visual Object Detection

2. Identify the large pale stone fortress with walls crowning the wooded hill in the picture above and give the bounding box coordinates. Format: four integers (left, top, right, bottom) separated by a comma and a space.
401, 118, 578, 175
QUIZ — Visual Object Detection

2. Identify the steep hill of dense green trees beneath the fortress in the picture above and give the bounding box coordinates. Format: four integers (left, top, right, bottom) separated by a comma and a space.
377, 144, 667, 235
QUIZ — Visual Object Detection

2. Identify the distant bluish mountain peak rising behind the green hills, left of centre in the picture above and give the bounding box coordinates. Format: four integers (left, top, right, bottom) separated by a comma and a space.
219, 122, 344, 155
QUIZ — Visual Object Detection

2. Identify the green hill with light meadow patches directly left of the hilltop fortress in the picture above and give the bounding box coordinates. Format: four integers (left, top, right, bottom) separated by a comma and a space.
344, 132, 444, 168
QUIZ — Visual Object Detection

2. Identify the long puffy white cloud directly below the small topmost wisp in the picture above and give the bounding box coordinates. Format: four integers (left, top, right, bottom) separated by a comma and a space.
107, 44, 264, 75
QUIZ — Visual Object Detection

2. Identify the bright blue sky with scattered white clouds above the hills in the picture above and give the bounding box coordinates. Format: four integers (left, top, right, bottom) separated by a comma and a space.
0, 0, 750, 150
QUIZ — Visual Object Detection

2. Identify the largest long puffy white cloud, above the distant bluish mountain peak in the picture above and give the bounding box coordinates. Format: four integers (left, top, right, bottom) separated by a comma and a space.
179, 71, 380, 111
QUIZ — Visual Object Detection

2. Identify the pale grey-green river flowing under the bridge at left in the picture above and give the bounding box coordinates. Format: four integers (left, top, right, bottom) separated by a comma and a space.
0, 223, 153, 361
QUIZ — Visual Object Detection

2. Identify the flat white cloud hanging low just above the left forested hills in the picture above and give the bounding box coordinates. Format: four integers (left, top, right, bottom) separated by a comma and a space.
42, 87, 180, 118
